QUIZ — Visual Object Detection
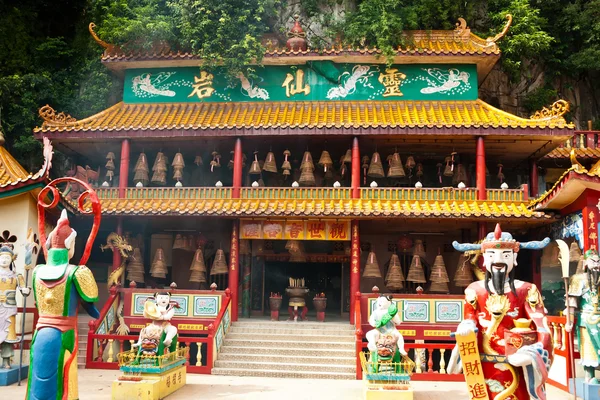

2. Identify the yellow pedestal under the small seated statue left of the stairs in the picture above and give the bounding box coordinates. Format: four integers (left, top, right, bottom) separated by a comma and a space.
112, 365, 186, 400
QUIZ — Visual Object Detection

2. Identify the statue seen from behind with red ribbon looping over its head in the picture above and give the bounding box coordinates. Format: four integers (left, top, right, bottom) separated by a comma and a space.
26, 178, 100, 400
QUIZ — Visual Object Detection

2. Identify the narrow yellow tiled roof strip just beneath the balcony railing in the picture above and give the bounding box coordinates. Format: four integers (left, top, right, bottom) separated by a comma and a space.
72, 199, 552, 219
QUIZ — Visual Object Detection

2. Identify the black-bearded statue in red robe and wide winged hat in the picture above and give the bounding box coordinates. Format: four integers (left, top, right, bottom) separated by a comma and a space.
448, 224, 552, 400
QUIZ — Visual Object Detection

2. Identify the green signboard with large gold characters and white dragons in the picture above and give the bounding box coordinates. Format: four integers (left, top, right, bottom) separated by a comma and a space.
123, 62, 477, 103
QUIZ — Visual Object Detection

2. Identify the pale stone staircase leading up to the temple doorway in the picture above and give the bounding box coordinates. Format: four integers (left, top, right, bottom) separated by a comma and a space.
212, 319, 356, 379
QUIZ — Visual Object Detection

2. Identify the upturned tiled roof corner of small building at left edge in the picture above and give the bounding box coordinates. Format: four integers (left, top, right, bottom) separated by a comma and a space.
0, 139, 52, 192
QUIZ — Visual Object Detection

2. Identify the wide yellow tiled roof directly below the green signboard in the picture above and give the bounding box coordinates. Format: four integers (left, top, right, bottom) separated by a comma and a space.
34, 100, 573, 133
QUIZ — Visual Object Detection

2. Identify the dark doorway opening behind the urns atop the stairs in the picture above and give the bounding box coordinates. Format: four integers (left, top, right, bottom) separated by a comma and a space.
265, 262, 348, 315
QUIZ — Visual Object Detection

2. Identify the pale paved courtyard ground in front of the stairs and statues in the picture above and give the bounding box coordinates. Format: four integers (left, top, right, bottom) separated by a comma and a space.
0, 369, 573, 400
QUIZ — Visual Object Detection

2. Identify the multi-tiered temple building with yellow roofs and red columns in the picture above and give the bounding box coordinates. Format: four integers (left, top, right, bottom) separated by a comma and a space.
28, 15, 600, 382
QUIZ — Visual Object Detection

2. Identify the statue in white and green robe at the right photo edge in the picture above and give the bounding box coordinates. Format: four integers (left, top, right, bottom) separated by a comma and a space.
565, 249, 600, 385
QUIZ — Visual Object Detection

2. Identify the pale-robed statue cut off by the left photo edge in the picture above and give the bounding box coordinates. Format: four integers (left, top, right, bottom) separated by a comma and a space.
0, 243, 31, 369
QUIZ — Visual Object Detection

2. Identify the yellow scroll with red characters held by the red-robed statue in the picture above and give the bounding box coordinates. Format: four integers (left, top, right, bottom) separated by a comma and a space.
454, 332, 490, 400
